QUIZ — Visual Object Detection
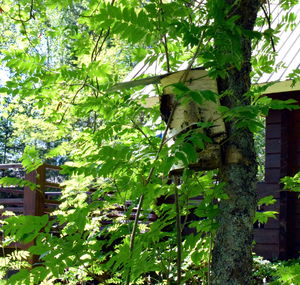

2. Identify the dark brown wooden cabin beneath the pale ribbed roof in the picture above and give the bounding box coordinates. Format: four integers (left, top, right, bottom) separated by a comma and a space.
254, 90, 300, 259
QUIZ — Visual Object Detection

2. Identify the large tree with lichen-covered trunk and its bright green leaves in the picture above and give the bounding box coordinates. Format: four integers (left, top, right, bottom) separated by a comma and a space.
0, 0, 298, 284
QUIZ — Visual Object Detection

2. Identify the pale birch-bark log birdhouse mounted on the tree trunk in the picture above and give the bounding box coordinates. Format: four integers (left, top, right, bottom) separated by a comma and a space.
160, 69, 226, 170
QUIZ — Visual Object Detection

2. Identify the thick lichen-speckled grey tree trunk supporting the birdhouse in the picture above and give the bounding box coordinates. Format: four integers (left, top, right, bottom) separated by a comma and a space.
212, 0, 260, 285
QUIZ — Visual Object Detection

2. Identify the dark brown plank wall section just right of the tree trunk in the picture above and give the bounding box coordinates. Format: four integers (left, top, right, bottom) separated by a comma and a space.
254, 110, 287, 259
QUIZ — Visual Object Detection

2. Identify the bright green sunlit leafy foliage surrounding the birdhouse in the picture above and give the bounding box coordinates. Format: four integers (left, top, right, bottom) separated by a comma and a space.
0, 0, 296, 284
